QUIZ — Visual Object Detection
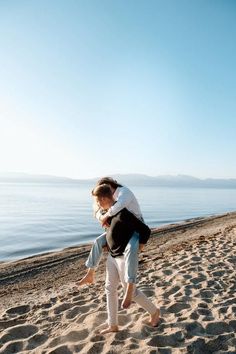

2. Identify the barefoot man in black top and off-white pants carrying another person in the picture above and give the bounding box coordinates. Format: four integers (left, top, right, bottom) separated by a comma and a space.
92, 184, 160, 334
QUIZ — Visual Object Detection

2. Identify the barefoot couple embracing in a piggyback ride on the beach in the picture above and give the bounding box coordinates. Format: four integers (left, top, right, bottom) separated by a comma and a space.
78, 177, 160, 334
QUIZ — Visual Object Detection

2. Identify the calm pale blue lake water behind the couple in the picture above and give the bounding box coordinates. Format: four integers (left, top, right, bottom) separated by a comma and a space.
0, 183, 236, 261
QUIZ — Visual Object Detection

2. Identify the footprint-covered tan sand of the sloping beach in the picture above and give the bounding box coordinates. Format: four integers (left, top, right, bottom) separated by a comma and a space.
0, 213, 236, 354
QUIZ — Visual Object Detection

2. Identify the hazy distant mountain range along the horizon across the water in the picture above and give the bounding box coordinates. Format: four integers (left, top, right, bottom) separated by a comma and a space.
0, 173, 236, 188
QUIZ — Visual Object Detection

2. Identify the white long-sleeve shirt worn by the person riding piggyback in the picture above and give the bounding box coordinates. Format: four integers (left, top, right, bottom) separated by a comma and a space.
96, 186, 142, 220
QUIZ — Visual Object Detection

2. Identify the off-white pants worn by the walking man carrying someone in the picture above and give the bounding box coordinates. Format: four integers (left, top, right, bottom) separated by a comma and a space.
105, 254, 157, 326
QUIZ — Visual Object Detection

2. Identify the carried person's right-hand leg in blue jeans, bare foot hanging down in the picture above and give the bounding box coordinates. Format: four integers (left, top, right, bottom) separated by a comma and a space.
122, 232, 139, 308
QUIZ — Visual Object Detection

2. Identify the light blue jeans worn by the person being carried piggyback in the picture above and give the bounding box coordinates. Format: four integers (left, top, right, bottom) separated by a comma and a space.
85, 232, 139, 283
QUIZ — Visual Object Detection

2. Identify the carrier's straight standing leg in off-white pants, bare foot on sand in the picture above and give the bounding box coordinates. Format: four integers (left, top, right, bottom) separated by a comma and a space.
100, 254, 120, 334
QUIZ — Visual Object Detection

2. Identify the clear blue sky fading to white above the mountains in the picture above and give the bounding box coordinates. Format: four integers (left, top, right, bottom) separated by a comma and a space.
0, 0, 236, 178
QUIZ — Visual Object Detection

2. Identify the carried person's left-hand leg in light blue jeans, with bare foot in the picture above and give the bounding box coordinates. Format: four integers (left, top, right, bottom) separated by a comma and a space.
78, 232, 106, 285
